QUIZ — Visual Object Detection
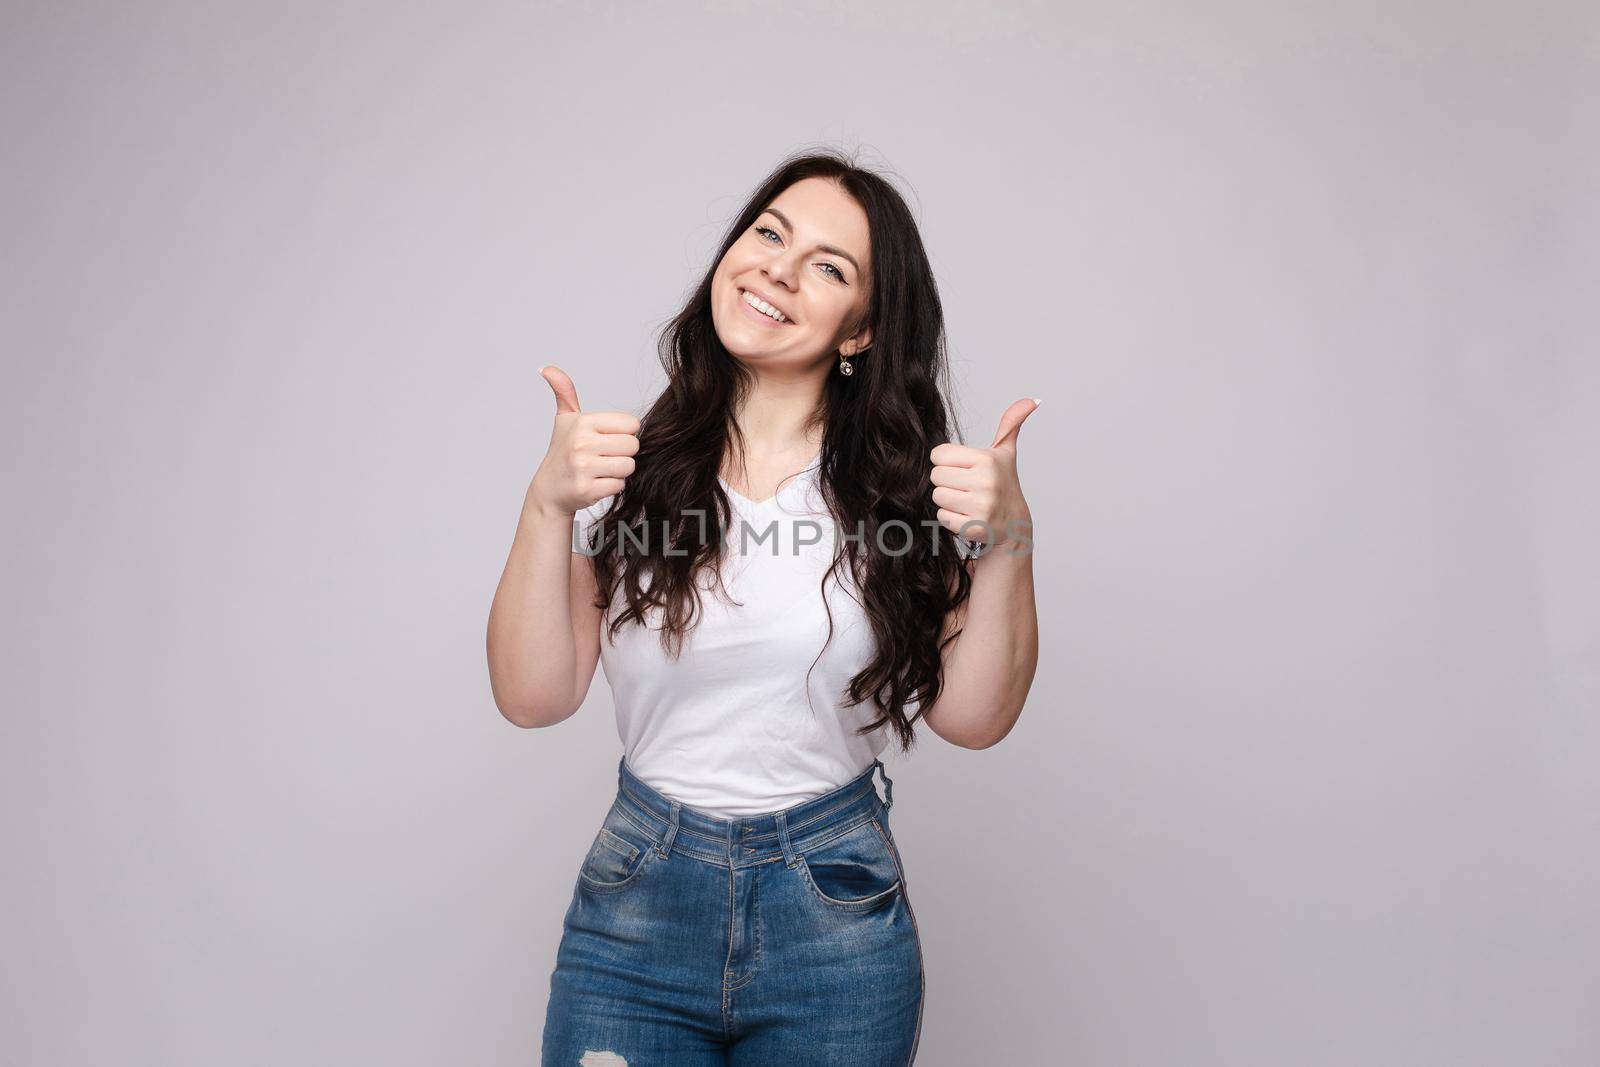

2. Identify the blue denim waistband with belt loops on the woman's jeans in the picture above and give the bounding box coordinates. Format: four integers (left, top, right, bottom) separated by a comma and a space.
604, 757, 894, 867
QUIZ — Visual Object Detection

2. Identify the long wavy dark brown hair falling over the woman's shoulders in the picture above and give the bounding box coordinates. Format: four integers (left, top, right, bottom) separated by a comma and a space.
589, 149, 971, 752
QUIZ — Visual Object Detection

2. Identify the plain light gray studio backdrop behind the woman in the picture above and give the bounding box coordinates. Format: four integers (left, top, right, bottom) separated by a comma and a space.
0, 0, 1600, 1067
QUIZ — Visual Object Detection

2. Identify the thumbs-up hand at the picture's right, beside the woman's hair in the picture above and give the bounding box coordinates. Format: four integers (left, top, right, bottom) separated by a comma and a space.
928, 397, 1040, 549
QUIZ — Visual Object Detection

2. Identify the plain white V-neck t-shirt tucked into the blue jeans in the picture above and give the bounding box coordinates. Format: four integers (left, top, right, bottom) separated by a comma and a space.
574, 459, 914, 819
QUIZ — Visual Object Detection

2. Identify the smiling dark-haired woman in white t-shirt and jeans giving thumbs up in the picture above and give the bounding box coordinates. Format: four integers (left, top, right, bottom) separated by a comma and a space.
488, 154, 1037, 1067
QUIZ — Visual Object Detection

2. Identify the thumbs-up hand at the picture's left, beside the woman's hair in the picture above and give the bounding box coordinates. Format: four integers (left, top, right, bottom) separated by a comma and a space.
523, 365, 638, 520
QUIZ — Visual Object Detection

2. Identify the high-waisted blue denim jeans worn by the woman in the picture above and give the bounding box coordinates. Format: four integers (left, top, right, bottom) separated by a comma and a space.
542, 760, 923, 1067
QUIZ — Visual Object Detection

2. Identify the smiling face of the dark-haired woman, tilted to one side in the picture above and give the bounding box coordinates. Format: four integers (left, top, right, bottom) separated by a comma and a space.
710, 178, 872, 371
